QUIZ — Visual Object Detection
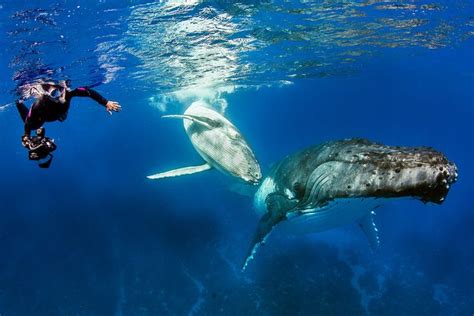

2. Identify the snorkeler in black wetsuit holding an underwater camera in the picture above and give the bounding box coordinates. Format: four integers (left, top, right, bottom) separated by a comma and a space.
16, 81, 122, 166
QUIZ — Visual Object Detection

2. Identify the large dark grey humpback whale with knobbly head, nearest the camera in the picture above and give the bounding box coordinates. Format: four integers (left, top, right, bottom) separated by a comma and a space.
242, 139, 457, 270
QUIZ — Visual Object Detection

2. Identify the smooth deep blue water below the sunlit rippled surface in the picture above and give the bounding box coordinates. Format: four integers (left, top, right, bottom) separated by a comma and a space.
0, 0, 474, 315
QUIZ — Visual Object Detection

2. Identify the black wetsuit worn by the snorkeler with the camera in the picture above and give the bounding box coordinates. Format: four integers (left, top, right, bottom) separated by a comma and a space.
16, 88, 107, 136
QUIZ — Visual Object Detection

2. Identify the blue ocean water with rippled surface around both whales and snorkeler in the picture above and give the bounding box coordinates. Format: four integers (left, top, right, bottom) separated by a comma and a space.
0, 0, 474, 316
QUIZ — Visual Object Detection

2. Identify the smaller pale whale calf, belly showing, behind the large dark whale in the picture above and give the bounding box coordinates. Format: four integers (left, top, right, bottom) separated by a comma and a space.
147, 102, 262, 185
